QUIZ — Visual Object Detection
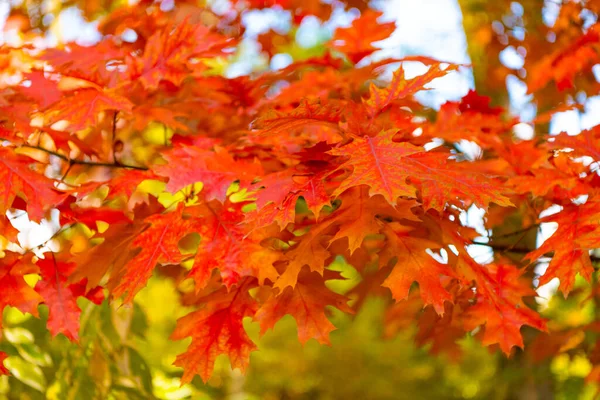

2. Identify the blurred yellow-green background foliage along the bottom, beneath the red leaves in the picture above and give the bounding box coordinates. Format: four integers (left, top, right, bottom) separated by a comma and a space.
0, 262, 597, 400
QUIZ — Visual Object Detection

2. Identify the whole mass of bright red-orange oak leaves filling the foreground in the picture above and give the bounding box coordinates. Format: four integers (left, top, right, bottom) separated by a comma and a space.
0, 0, 600, 383
